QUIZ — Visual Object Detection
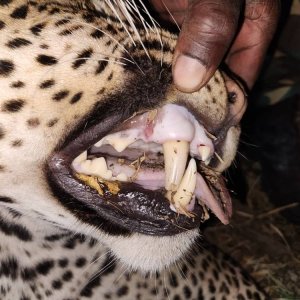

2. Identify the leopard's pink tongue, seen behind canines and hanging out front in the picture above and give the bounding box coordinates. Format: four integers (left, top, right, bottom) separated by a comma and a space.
107, 157, 231, 224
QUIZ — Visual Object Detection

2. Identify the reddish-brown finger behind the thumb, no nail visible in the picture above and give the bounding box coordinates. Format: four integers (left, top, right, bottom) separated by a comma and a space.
226, 0, 280, 88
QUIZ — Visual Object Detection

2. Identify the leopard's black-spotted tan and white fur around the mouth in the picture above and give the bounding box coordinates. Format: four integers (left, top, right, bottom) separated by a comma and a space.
0, 0, 266, 300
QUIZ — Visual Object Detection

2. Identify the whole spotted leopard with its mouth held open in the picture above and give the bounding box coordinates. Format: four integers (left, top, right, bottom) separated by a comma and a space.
0, 0, 267, 300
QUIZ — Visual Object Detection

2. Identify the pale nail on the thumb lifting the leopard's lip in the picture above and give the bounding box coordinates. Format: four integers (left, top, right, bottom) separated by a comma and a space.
173, 55, 207, 92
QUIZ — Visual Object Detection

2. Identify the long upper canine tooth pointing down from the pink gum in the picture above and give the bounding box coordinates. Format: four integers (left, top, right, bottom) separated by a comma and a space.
163, 141, 189, 191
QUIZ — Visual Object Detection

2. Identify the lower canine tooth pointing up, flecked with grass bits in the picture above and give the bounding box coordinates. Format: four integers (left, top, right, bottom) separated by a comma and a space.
173, 158, 197, 208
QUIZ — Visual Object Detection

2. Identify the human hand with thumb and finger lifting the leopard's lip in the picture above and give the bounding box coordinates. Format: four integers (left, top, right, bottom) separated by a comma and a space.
151, 0, 280, 92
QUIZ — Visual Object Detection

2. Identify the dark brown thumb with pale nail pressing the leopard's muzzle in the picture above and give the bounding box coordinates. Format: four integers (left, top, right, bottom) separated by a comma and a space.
173, 0, 243, 92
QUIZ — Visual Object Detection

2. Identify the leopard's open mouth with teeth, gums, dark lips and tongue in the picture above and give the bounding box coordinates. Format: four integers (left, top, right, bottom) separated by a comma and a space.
49, 104, 231, 235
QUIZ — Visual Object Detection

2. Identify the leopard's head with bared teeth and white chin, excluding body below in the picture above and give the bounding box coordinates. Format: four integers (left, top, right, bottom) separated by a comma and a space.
0, 0, 245, 271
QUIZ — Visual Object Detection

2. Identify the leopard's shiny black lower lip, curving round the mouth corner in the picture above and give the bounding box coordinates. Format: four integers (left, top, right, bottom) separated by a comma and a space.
48, 115, 203, 236
